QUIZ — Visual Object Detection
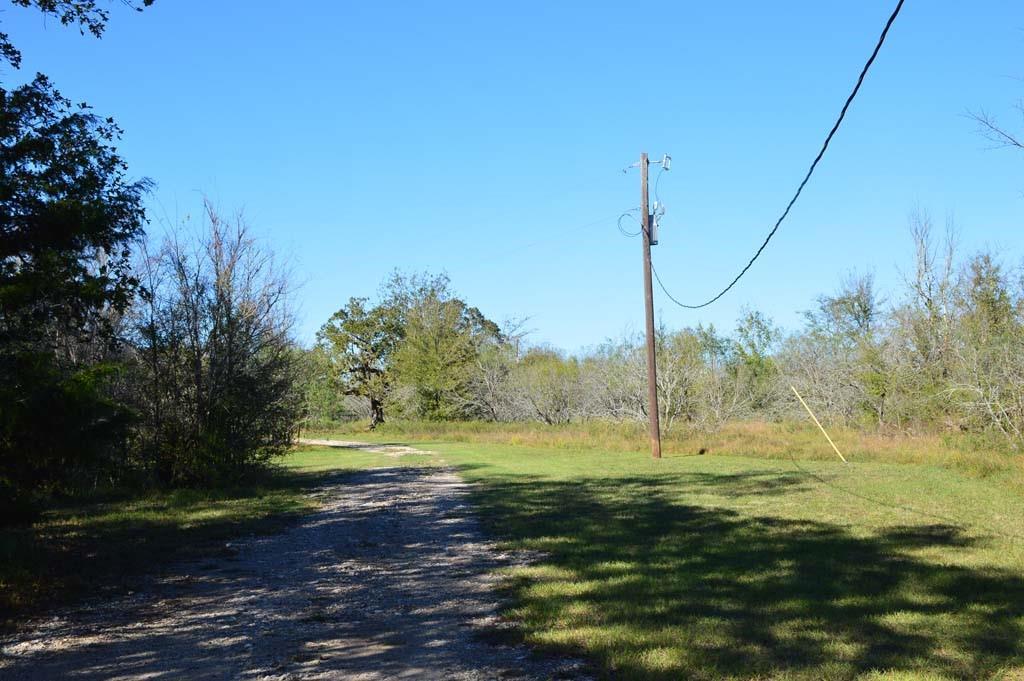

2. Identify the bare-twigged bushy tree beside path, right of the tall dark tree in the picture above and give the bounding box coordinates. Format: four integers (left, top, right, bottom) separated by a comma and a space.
133, 203, 302, 483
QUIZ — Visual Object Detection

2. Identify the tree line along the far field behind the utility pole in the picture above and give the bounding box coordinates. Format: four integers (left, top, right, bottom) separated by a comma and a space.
306, 214, 1024, 443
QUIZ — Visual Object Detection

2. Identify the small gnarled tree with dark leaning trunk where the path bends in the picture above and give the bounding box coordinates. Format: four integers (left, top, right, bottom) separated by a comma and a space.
316, 298, 404, 430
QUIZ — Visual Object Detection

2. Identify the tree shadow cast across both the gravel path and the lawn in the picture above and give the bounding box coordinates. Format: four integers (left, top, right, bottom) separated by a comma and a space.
0, 464, 1024, 680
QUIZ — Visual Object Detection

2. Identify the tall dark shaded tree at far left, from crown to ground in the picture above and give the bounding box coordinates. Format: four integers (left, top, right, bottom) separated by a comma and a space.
0, 71, 150, 512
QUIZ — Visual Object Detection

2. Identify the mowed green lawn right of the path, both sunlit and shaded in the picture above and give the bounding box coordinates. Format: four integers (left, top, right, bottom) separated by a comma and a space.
407, 442, 1024, 679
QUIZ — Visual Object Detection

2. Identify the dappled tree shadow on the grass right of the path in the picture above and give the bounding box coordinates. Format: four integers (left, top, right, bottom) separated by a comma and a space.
467, 469, 1024, 679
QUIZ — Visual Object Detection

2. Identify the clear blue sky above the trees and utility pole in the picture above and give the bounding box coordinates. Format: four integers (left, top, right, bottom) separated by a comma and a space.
0, 0, 1024, 350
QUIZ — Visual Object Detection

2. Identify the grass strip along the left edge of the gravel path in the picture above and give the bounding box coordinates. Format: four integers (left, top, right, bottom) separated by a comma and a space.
0, 448, 407, 628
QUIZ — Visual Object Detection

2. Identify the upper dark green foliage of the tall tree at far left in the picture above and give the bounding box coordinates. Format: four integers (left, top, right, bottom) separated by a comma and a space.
0, 76, 148, 347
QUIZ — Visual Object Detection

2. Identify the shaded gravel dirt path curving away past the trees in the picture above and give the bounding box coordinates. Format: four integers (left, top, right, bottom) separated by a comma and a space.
0, 442, 583, 681
